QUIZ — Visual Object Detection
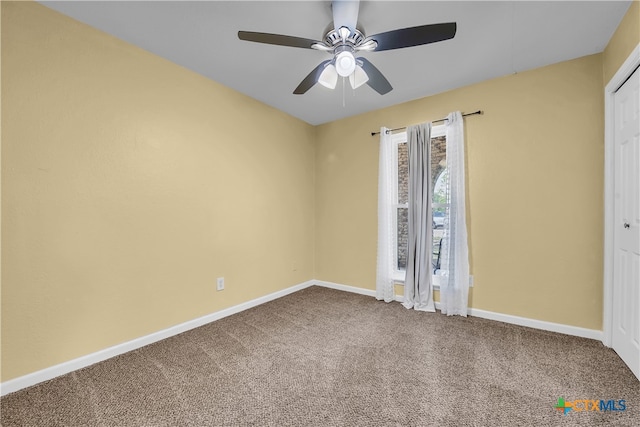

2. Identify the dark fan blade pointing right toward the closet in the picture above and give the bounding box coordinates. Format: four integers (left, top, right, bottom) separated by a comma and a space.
367, 22, 457, 52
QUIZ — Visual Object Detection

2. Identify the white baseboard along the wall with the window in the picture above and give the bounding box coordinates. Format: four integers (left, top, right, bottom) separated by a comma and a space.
315, 280, 603, 341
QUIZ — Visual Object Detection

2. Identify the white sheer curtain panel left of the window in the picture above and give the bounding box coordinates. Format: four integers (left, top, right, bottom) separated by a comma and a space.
376, 127, 395, 302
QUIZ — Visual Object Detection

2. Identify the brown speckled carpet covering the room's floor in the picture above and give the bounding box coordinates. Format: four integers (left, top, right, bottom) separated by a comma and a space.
0, 287, 640, 427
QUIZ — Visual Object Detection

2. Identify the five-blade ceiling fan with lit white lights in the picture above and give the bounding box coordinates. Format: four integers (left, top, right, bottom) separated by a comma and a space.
238, 0, 456, 95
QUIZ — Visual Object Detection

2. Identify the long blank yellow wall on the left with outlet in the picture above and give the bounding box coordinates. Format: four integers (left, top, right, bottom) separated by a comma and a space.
2, 2, 315, 381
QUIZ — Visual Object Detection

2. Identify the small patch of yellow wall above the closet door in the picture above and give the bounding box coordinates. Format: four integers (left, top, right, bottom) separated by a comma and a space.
602, 0, 640, 86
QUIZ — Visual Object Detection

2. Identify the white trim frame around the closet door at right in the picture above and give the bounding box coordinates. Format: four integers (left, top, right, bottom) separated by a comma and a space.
602, 44, 640, 347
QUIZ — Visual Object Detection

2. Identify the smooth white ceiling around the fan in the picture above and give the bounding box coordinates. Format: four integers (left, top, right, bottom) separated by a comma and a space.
42, 1, 631, 125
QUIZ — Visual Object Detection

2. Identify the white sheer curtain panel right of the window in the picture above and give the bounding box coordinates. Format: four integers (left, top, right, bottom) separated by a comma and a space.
440, 111, 469, 317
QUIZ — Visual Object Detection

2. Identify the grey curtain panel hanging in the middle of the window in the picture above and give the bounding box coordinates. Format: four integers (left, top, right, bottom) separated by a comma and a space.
402, 123, 436, 312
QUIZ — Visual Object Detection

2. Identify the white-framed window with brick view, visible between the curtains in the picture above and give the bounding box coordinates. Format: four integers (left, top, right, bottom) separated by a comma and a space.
392, 125, 449, 282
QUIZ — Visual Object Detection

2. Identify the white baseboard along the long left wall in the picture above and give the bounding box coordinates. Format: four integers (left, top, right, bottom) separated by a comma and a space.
0, 280, 314, 396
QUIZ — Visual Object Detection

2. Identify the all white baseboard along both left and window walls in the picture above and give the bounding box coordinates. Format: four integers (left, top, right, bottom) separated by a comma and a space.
0, 280, 602, 396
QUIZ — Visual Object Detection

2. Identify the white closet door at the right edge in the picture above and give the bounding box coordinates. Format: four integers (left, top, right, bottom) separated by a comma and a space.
612, 69, 640, 379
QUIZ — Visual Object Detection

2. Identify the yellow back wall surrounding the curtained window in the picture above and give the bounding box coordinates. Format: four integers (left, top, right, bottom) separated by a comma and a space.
316, 54, 604, 329
